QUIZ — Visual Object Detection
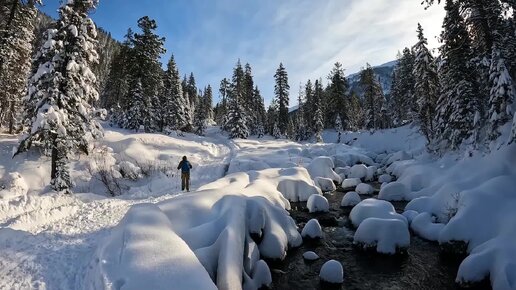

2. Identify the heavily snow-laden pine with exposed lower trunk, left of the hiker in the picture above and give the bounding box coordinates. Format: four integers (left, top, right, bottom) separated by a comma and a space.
14, 0, 102, 191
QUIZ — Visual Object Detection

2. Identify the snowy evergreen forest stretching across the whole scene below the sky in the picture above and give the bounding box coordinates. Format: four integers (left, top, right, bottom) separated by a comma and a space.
0, 0, 516, 190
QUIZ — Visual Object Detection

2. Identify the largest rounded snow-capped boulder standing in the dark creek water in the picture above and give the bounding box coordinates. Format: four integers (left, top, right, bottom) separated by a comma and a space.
353, 218, 410, 254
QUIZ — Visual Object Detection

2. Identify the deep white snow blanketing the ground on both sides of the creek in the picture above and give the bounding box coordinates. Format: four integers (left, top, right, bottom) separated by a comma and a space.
0, 127, 516, 289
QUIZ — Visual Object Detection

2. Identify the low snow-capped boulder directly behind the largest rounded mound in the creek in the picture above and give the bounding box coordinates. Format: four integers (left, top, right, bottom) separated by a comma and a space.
349, 198, 408, 228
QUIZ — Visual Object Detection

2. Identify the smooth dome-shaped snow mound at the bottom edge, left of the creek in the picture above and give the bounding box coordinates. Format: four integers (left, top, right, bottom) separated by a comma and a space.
85, 204, 217, 290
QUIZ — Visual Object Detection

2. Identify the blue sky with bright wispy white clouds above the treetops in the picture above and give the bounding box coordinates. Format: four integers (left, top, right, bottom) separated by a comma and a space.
41, 0, 444, 105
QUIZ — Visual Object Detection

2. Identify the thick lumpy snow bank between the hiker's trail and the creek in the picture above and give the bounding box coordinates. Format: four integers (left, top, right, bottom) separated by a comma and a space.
88, 168, 322, 289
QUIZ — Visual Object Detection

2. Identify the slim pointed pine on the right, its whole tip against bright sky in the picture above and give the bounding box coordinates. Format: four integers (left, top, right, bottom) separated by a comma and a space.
413, 24, 439, 142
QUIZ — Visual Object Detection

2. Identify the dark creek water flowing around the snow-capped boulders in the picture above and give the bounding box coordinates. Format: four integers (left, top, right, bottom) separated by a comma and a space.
269, 186, 490, 290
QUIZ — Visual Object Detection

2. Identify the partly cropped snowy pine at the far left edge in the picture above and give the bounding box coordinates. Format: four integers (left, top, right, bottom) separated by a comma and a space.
0, 0, 41, 134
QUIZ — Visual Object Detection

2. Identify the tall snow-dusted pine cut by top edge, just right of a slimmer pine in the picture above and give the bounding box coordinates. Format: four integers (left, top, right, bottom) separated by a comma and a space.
436, 0, 477, 151
